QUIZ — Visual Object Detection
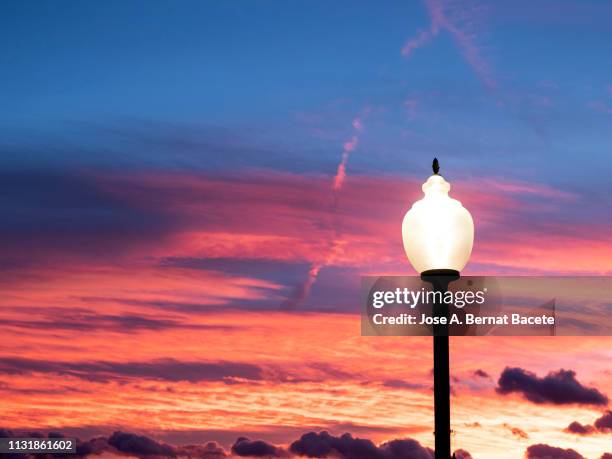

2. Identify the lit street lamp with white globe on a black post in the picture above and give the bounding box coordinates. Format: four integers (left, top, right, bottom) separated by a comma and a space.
402, 158, 474, 459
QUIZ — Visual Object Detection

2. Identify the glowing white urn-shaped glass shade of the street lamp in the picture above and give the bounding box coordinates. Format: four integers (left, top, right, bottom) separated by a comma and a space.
402, 174, 474, 273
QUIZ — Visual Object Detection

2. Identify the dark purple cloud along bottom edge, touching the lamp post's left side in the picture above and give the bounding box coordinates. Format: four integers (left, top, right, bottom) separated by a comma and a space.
289, 432, 433, 459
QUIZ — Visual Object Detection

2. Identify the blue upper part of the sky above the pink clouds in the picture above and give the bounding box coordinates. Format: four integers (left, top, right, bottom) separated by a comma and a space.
0, 1, 612, 186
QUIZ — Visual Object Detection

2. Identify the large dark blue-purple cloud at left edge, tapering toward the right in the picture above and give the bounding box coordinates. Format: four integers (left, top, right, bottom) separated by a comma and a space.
0, 169, 176, 260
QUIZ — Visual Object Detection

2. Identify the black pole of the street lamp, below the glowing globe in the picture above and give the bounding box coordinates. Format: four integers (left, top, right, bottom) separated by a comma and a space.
421, 269, 459, 459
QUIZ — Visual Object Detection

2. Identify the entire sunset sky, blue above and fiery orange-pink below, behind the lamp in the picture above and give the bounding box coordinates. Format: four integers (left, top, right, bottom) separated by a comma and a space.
0, 0, 612, 459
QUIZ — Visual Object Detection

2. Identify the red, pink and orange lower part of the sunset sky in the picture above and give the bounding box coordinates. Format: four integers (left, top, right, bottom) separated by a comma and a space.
0, 171, 612, 458
